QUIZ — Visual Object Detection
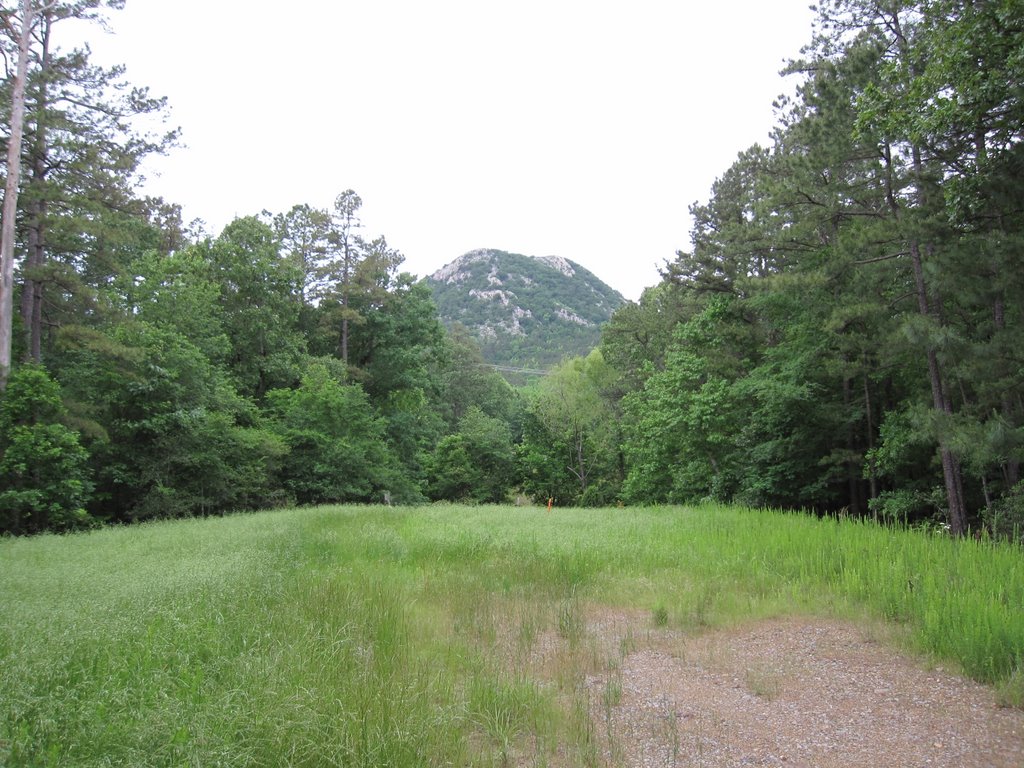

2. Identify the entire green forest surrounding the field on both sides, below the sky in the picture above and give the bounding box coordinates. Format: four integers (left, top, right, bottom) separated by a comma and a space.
0, 0, 1024, 535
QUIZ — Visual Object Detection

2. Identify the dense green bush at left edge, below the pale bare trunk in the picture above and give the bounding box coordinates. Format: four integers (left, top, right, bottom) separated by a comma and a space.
0, 366, 93, 534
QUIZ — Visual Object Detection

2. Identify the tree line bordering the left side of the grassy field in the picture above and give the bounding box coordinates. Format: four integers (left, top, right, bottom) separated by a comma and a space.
0, 0, 536, 534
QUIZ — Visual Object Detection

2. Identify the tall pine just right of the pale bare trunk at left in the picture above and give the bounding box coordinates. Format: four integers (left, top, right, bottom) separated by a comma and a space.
11, 2, 177, 370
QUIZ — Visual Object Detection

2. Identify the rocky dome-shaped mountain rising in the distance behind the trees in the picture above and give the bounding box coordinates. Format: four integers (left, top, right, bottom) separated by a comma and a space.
426, 249, 625, 368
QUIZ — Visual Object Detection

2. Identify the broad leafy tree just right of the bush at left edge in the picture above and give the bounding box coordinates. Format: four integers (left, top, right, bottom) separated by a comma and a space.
60, 322, 284, 520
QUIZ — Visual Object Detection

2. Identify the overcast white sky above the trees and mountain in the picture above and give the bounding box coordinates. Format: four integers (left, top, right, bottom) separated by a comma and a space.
77, 0, 812, 299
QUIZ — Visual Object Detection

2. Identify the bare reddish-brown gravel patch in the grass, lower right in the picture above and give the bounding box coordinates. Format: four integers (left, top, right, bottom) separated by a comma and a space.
577, 610, 1024, 768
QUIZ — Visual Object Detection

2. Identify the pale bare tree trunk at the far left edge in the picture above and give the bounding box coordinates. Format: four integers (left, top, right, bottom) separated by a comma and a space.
0, 0, 33, 392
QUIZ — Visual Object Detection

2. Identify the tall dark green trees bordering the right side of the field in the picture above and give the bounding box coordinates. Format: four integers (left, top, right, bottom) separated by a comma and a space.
604, 0, 1024, 534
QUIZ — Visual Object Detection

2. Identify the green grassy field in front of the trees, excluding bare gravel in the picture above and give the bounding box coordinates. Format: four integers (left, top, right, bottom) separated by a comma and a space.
6, 506, 1024, 766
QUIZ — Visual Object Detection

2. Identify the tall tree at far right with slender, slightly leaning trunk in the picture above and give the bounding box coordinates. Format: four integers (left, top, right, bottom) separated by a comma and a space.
802, 0, 1022, 534
